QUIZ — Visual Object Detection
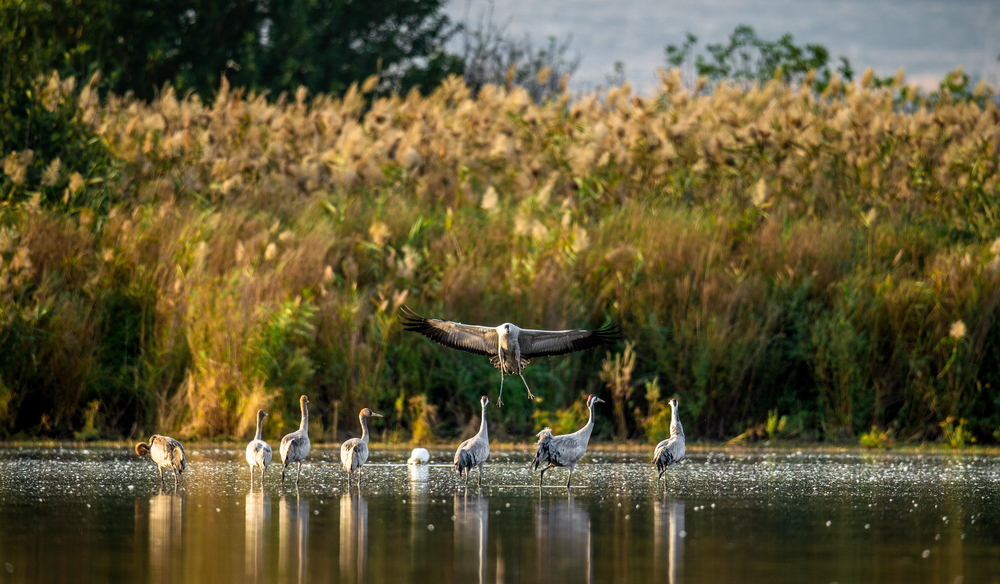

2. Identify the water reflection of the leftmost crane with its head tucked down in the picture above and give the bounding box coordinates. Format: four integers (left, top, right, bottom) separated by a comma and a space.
149, 491, 184, 583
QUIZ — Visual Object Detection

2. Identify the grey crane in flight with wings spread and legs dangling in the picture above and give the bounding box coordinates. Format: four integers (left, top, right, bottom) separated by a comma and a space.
400, 306, 622, 406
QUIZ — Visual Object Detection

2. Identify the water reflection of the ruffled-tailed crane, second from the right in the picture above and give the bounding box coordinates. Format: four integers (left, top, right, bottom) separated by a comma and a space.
535, 494, 593, 582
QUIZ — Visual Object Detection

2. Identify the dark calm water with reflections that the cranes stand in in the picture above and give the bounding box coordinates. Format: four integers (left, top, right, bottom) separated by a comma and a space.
0, 448, 1000, 584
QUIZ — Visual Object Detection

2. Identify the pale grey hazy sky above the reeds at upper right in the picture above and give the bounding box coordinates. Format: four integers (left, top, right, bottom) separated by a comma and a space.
445, 0, 1000, 92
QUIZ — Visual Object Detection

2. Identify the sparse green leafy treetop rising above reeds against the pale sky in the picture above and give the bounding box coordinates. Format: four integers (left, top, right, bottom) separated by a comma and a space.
666, 25, 854, 89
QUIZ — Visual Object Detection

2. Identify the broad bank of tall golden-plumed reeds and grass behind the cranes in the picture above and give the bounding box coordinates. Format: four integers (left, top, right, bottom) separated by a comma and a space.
0, 72, 1000, 443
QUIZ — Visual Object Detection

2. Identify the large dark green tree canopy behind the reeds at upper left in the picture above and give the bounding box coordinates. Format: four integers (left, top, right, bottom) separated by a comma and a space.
0, 0, 461, 99
